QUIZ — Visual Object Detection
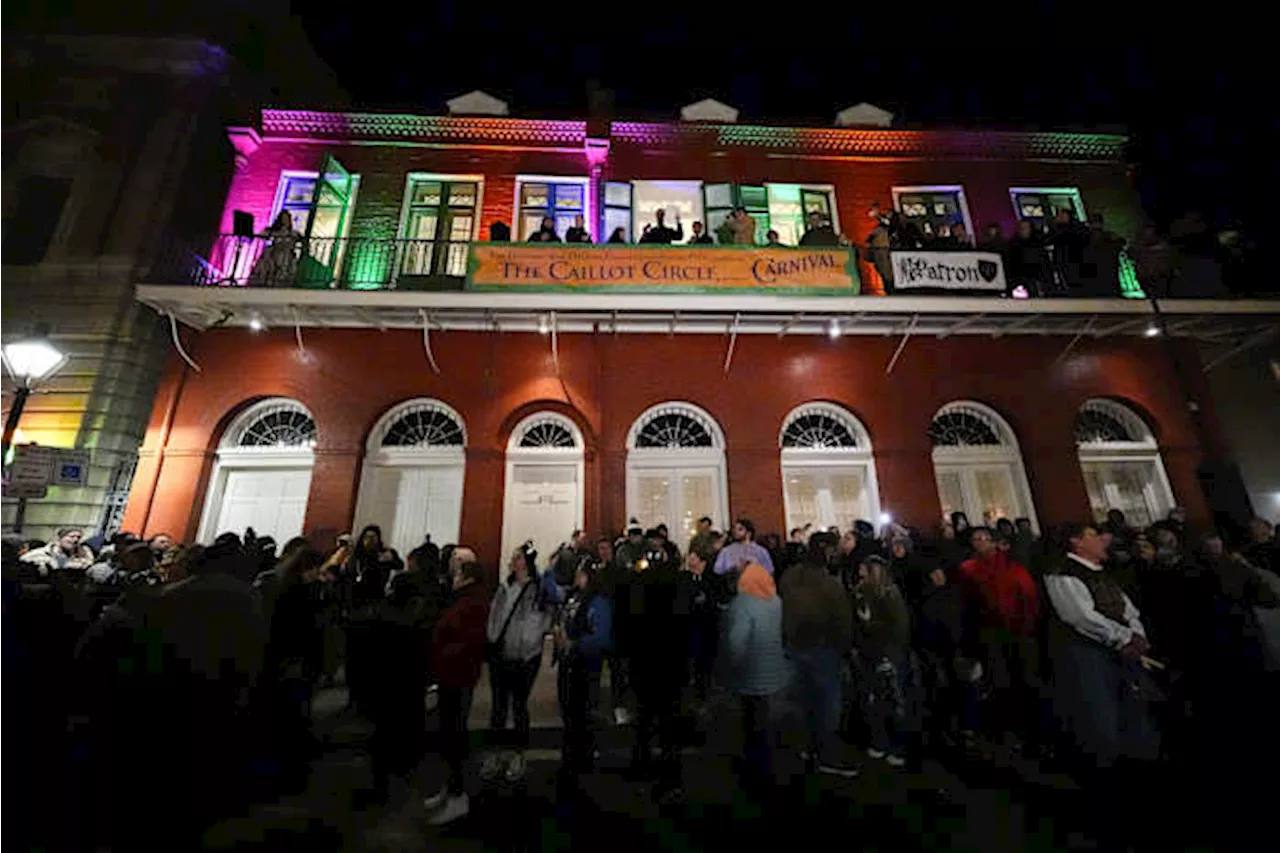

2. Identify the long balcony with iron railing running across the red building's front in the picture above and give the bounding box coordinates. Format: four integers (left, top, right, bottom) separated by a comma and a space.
138, 237, 1280, 346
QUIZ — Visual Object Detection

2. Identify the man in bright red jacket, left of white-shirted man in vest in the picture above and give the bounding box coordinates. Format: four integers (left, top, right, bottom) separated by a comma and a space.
960, 528, 1039, 738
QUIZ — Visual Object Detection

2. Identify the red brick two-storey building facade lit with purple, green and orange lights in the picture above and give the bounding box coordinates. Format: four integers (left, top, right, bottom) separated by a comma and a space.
125, 101, 1275, 561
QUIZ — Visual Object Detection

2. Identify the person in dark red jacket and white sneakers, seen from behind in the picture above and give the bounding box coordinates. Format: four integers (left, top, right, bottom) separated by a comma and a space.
424, 548, 489, 825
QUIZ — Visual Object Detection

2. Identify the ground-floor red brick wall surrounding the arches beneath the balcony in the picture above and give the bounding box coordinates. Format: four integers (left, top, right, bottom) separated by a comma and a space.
125, 329, 1208, 557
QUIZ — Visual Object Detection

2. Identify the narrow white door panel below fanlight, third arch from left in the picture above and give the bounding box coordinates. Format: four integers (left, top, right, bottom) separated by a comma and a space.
500, 462, 580, 560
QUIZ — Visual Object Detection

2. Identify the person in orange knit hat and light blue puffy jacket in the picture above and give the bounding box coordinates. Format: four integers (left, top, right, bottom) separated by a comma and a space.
724, 561, 790, 790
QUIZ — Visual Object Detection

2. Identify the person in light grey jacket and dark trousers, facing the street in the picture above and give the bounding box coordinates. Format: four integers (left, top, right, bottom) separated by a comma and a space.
481, 543, 552, 779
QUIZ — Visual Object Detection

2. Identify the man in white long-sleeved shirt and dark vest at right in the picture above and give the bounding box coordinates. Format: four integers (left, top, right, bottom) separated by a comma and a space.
1044, 524, 1160, 768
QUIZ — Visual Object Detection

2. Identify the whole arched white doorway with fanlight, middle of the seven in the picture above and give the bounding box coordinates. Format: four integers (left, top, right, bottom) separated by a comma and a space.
627, 402, 728, 540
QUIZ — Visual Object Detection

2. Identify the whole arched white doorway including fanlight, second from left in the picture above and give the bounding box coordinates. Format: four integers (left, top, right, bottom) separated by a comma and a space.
355, 397, 467, 556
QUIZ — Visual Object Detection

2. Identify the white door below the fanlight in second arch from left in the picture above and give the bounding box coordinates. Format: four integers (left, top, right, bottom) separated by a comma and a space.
356, 465, 462, 557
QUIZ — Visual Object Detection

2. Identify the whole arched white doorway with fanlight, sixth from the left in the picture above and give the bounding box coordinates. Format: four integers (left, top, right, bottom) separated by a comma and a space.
928, 401, 1038, 528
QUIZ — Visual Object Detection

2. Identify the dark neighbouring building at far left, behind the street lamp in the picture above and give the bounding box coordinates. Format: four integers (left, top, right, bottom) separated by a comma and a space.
0, 36, 230, 537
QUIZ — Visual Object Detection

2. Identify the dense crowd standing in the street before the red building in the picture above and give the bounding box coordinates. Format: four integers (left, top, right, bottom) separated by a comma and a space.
0, 511, 1280, 849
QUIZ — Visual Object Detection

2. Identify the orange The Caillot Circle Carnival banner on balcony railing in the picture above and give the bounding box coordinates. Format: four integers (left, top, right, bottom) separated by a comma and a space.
467, 243, 859, 295
